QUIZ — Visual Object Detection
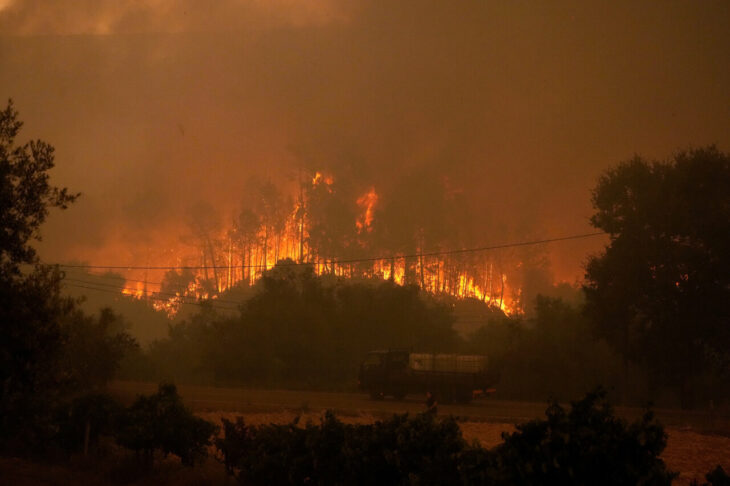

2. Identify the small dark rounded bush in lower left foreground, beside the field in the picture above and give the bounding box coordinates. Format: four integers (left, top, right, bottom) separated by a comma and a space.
117, 384, 217, 466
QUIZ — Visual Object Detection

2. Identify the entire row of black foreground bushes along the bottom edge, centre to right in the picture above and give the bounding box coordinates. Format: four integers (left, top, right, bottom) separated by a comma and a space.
216, 391, 675, 485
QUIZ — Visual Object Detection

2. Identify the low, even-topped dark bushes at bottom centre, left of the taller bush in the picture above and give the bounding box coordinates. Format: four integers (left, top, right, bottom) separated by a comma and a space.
216, 412, 465, 485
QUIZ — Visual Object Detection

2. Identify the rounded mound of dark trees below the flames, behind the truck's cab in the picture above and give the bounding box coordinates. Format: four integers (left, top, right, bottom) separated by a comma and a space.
122, 261, 460, 388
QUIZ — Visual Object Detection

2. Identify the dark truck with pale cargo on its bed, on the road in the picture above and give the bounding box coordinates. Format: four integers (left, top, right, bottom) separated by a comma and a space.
358, 349, 496, 403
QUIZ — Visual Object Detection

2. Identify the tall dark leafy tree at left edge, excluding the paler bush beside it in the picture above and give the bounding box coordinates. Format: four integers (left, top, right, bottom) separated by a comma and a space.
0, 98, 78, 448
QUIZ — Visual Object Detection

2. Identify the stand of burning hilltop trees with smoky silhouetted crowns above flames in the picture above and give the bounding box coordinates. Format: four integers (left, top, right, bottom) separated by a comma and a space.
111, 165, 519, 318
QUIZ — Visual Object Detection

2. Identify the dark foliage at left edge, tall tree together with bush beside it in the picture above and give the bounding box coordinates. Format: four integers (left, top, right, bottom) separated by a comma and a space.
0, 102, 134, 452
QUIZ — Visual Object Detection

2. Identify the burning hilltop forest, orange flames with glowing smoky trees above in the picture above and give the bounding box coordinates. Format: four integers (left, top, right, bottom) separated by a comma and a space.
101, 171, 521, 316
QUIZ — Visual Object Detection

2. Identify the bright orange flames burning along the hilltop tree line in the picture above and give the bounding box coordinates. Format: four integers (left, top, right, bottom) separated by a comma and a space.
105, 172, 519, 316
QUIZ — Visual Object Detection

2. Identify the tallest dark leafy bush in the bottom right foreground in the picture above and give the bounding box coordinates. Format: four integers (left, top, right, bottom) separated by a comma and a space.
461, 389, 676, 486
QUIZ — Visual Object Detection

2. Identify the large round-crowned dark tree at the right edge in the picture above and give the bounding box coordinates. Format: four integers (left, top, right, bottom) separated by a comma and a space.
585, 147, 730, 406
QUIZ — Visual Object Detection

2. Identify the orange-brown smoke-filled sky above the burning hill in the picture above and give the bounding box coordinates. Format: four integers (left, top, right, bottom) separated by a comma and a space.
0, 0, 730, 281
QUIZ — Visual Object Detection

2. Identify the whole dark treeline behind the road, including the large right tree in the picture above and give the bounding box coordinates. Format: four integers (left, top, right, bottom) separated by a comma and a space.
112, 147, 730, 408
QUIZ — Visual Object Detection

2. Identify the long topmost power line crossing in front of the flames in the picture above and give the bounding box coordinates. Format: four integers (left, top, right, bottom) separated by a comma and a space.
57, 231, 606, 270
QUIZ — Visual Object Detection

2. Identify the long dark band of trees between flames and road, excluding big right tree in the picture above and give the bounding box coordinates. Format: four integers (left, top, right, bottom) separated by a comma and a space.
112, 265, 676, 404
